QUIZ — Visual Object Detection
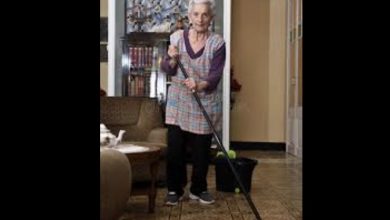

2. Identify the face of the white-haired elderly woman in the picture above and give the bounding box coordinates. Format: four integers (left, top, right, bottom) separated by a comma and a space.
189, 4, 213, 32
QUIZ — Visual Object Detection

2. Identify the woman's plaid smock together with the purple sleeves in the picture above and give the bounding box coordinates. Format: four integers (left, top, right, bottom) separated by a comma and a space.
162, 30, 225, 134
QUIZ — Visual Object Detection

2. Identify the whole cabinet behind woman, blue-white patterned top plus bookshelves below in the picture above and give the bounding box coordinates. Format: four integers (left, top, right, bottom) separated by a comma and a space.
121, 0, 188, 102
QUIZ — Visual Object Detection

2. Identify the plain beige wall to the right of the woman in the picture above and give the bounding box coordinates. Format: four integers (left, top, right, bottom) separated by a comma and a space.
230, 0, 286, 142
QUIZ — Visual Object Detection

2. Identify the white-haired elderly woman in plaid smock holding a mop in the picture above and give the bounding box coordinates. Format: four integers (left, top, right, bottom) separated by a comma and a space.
161, 0, 225, 205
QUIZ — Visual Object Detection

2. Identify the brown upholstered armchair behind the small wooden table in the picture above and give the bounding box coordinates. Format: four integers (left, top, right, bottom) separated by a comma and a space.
100, 96, 167, 183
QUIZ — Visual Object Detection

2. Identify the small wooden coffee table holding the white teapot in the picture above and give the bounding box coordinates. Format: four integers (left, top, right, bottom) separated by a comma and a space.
115, 143, 161, 213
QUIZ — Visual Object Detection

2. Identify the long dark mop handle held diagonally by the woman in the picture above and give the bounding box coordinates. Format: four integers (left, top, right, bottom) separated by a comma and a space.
176, 58, 261, 220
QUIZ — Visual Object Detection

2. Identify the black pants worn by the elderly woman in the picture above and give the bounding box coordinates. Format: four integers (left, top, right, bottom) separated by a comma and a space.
167, 125, 212, 195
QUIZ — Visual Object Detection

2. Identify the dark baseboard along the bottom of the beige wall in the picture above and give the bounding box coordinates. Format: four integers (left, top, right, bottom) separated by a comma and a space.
230, 141, 286, 151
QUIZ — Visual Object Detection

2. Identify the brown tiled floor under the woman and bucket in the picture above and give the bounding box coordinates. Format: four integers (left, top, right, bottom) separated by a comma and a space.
120, 150, 302, 220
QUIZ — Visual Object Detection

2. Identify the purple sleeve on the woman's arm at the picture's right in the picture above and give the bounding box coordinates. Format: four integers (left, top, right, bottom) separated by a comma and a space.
205, 44, 226, 93
